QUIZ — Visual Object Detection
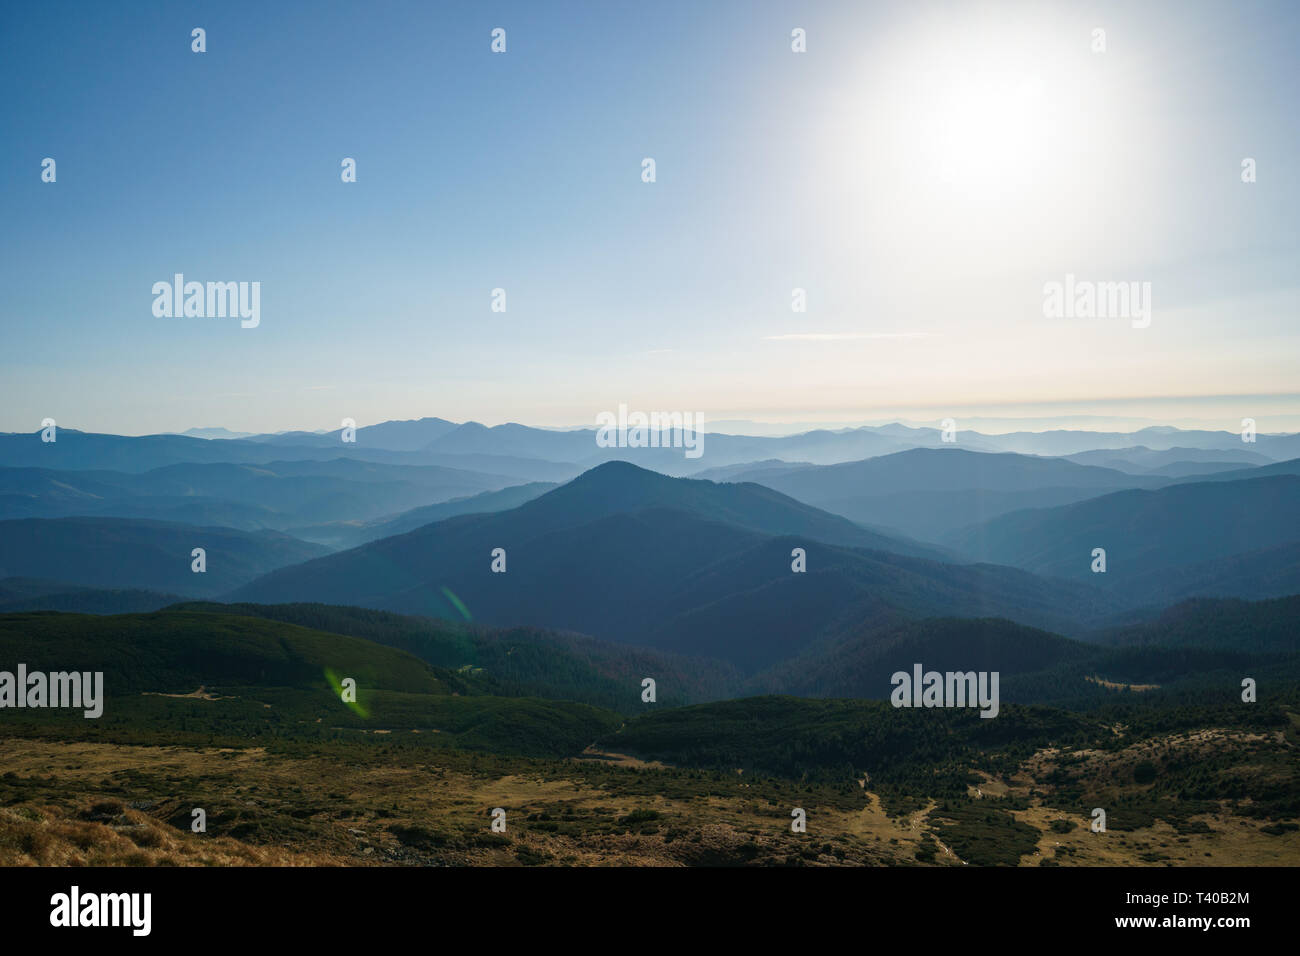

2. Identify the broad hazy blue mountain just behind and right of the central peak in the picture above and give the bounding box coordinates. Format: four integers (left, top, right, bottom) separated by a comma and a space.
712, 447, 1165, 541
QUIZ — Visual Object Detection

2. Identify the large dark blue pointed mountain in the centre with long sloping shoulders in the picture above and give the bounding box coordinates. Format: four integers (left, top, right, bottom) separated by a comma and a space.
226, 463, 1097, 667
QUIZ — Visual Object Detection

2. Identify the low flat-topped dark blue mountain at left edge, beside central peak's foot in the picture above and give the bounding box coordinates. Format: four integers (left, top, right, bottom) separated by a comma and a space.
0, 518, 328, 596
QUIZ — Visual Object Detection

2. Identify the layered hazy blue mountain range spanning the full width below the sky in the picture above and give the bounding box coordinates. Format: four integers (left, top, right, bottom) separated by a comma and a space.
0, 419, 1300, 675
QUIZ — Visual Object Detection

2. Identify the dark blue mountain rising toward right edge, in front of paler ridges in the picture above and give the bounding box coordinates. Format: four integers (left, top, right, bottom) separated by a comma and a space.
946, 475, 1300, 597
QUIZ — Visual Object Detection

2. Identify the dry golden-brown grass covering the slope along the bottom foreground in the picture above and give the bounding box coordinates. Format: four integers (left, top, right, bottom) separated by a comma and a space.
0, 731, 1300, 866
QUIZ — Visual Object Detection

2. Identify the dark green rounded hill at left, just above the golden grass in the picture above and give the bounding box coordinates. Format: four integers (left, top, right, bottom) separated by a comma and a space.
0, 611, 621, 757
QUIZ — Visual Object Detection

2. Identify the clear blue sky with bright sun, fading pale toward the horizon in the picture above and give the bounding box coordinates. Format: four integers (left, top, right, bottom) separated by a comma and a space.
0, 0, 1300, 434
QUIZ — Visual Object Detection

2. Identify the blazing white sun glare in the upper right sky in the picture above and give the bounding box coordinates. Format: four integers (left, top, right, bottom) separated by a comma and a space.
819, 12, 1149, 278
